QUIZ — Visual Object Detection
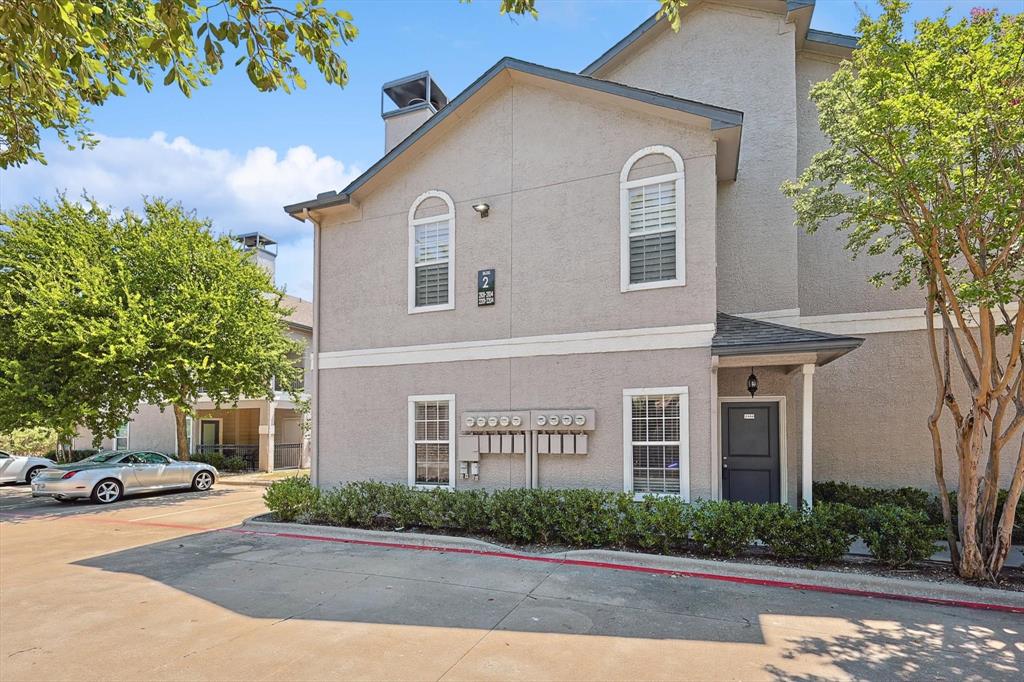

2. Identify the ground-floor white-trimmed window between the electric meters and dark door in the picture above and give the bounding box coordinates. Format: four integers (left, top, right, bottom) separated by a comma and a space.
623, 387, 689, 499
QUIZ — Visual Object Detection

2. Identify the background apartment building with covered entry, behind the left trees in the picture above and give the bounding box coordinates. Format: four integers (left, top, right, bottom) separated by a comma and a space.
72, 232, 313, 471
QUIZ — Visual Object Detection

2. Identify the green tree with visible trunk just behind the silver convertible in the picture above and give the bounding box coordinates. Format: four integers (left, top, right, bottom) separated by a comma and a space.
121, 199, 303, 458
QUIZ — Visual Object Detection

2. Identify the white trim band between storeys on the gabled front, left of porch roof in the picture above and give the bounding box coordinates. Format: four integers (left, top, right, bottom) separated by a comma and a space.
318, 323, 715, 370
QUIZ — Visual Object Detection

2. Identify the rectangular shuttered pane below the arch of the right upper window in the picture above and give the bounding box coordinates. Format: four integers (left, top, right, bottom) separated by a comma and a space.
629, 180, 677, 284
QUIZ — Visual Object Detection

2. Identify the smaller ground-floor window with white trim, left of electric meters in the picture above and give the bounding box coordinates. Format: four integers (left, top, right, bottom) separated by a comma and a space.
409, 395, 455, 486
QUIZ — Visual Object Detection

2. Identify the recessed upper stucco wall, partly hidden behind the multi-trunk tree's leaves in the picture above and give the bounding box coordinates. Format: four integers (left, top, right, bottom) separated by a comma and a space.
797, 52, 924, 315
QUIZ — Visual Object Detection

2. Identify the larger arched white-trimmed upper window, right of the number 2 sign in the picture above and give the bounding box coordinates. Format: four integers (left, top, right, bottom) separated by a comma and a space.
618, 144, 686, 292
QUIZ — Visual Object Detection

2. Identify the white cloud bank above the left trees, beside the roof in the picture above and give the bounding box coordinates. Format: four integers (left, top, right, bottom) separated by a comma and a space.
0, 132, 358, 298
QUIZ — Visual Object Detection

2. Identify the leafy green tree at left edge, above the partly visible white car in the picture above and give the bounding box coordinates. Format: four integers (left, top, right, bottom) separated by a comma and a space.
0, 197, 146, 438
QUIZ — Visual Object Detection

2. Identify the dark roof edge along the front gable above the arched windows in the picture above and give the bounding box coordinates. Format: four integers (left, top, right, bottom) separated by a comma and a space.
285, 57, 743, 220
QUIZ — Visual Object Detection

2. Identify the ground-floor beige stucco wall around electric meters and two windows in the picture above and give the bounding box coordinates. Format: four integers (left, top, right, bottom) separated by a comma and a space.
319, 349, 711, 498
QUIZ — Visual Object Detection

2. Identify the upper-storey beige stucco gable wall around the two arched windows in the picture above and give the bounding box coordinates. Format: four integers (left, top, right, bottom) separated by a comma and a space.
319, 82, 716, 351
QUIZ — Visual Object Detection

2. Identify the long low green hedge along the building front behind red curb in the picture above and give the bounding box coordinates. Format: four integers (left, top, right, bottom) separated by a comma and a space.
263, 476, 941, 566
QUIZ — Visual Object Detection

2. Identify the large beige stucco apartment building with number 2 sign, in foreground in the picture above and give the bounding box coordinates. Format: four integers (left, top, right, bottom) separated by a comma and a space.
286, 0, 1011, 502
